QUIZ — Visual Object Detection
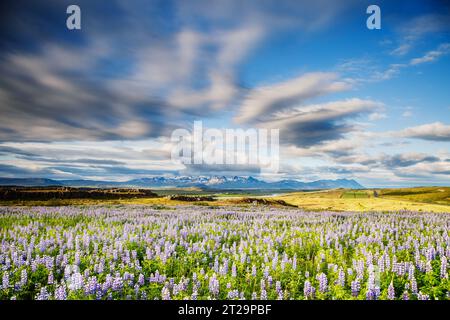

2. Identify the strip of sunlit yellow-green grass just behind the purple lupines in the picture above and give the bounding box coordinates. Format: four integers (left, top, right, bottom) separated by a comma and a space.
0, 187, 450, 212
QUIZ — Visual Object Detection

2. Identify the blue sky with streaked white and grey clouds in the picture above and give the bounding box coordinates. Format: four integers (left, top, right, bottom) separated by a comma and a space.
0, 0, 450, 187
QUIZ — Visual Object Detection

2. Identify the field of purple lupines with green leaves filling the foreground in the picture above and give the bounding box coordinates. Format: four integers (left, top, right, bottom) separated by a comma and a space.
0, 206, 450, 300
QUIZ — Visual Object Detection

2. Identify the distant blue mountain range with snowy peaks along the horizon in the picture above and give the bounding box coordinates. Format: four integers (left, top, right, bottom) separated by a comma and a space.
0, 176, 364, 190
